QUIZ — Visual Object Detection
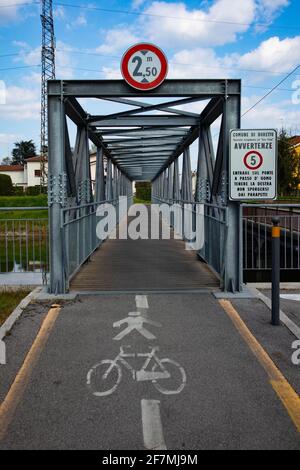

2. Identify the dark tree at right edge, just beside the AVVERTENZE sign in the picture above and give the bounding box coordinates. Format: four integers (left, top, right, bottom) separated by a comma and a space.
278, 129, 299, 196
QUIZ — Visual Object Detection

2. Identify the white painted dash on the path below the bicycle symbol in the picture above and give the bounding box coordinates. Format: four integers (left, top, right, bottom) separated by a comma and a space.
141, 399, 167, 450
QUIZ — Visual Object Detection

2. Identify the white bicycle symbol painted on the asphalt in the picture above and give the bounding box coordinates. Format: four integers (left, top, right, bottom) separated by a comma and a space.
87, 346, 186, 397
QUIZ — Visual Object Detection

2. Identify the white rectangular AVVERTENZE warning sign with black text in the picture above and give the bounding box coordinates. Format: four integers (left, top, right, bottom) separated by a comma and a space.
229, 129, 277, 201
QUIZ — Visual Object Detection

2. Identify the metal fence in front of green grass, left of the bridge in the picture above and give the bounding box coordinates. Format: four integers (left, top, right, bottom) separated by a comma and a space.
0, 207, 49, 282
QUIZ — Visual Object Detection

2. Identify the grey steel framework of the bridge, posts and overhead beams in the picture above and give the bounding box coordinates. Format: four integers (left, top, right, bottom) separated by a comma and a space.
48, 79, 242, 293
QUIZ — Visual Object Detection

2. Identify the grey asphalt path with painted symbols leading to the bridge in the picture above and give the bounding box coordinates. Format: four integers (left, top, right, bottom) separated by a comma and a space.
0, 293, 300, 450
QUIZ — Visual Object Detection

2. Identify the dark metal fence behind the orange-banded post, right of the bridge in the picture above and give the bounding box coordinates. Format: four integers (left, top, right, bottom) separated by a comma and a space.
242, 204, 300, 280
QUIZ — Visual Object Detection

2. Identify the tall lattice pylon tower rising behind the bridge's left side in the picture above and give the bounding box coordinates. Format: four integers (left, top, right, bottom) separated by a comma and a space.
40, 0, 55, 191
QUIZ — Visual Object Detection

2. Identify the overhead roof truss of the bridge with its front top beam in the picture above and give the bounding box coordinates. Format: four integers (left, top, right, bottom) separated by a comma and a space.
48, 80, 240, 183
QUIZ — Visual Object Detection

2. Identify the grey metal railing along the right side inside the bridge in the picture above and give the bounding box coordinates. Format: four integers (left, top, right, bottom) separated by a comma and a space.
153, 197, 228, 286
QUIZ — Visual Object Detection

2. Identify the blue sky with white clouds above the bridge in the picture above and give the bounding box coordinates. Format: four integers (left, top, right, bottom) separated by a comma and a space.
0, 0, 300, 165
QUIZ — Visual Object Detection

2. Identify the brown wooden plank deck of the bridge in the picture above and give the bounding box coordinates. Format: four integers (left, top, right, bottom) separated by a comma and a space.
70, 235, 219, 291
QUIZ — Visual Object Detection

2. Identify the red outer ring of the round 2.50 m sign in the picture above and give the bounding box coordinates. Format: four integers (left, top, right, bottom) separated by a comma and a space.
121, 43, 168, 91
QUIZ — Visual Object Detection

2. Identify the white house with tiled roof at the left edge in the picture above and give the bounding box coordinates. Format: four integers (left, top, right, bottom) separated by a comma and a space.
0, 156, 46, 189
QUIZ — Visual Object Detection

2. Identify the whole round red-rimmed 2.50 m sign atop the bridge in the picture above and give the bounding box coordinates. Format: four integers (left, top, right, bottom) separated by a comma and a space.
121, 43, 168, 91
